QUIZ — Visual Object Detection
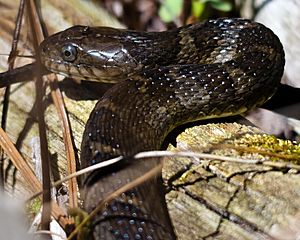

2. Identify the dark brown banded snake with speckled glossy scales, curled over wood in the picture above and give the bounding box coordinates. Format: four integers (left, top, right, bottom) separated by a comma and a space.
41, 19, 284, 240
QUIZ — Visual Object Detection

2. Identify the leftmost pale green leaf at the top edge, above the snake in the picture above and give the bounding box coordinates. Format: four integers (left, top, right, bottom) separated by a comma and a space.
158, 0, 183, 22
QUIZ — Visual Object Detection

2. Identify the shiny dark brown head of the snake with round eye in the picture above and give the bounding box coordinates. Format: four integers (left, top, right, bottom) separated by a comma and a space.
40, 26, 139, 83
